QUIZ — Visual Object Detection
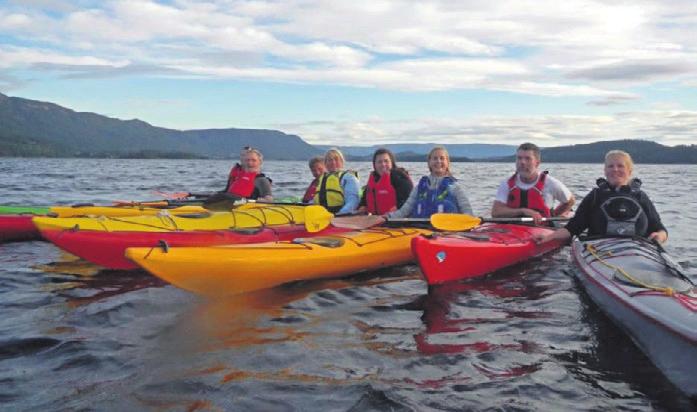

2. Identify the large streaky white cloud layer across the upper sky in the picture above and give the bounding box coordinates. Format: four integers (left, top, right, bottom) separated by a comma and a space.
0, 0, 697, 100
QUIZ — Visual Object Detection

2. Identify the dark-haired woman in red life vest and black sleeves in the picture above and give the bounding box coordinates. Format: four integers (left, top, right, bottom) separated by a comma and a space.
358, 148, 414, 215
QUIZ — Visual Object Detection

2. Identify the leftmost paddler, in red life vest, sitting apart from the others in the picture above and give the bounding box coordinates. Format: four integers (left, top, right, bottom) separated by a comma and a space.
223, 146, 273, 202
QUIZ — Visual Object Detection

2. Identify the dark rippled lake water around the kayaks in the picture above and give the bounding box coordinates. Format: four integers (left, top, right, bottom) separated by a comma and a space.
0, 159, 697, 411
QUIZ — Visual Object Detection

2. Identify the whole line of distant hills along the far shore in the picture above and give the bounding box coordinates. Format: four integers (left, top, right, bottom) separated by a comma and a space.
0, 93, 697, 164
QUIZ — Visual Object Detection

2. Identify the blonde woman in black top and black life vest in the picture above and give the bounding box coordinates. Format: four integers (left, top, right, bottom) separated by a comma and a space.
535, 150, 668, 243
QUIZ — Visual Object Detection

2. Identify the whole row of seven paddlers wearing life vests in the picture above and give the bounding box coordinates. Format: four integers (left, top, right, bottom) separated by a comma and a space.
220, 143, 668, 243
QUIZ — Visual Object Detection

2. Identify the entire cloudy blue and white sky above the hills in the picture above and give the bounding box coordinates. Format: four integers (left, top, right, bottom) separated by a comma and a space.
0, 0, 697, 146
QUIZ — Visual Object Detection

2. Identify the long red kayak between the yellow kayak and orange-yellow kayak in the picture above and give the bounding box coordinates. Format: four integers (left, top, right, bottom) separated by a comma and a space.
41, 225, 349, 269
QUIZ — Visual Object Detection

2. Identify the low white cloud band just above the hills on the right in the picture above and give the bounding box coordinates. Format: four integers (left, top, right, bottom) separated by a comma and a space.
275, 111, 697, 146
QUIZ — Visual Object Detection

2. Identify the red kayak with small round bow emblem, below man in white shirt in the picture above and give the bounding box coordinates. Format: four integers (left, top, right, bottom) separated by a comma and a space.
411, 223, 564, 285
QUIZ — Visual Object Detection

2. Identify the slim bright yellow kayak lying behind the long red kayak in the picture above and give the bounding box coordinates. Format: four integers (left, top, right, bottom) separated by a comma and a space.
33, 205, 305, 232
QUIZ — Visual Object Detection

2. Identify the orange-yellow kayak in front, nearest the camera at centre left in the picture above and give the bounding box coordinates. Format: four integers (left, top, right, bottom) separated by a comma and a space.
126, 227, 431, 296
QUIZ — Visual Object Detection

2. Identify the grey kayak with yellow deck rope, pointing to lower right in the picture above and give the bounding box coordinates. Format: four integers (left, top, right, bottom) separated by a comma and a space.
572, 239, 697, 397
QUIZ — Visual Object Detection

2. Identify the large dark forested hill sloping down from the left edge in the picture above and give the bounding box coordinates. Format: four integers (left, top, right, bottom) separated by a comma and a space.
0, 94, 320, 160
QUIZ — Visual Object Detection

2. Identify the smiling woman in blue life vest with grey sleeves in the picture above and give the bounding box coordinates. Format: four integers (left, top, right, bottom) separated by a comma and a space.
386, 146, 472, 218
